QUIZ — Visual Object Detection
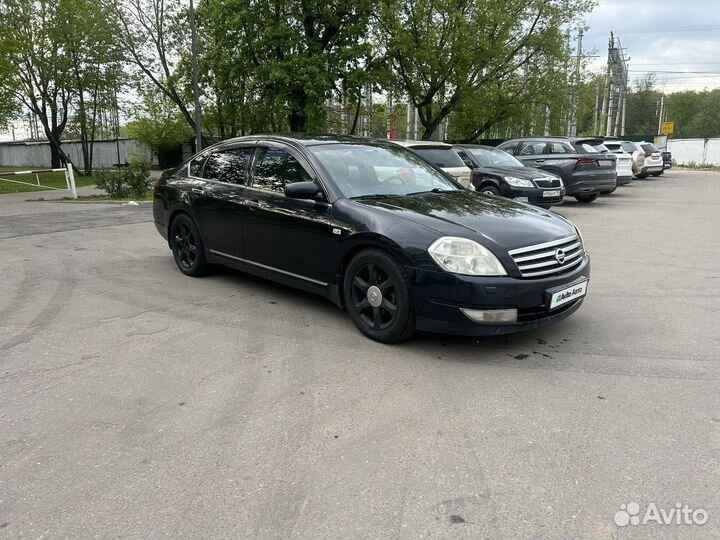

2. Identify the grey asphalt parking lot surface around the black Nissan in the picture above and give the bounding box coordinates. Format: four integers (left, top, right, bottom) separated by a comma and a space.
0, 170, 720, 540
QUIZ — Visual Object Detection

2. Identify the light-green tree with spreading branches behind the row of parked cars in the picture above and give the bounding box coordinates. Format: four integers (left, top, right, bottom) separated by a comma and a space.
377, 0, 593, 139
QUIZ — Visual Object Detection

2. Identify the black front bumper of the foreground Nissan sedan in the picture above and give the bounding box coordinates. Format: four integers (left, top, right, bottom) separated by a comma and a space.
407, 255, 590, 336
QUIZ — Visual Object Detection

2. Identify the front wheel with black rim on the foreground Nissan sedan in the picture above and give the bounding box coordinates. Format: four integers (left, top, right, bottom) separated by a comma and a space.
343, 249, 415, 343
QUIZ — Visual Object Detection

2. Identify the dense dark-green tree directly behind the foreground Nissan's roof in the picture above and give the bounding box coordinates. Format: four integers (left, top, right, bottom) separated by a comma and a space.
198, 0, 373, 132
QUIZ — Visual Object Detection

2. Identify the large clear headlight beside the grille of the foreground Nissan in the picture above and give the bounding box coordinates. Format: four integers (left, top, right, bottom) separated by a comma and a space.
428, 236, 507, 276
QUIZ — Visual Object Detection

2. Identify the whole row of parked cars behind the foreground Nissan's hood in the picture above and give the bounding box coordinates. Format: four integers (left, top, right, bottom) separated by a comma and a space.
395, 137, 672, 208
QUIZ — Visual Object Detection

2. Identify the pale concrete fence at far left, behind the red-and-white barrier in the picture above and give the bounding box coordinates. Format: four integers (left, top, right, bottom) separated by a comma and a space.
0, 139, 157, 170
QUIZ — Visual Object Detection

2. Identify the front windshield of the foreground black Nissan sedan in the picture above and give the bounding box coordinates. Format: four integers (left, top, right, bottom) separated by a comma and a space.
309, 144, 464, 197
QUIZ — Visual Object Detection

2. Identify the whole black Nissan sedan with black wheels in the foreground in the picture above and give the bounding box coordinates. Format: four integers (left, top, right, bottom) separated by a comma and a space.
153, 135, 590, 343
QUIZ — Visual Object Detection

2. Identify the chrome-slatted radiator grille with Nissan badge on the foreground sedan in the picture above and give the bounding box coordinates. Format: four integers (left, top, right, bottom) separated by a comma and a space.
509, 236, 585, 277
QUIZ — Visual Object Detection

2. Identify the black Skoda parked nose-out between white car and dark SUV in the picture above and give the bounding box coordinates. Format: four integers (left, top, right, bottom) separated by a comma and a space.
453, 144, 565, 208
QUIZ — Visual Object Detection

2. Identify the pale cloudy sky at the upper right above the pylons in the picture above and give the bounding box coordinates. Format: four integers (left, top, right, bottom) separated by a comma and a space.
576, 0, 720, 93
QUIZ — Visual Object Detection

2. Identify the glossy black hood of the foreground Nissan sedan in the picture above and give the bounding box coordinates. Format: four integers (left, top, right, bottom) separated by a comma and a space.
358, 191, 575, 251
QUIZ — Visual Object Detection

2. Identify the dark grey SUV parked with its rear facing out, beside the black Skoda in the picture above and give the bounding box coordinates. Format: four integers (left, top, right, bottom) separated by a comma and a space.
498, 137, 617, 203
